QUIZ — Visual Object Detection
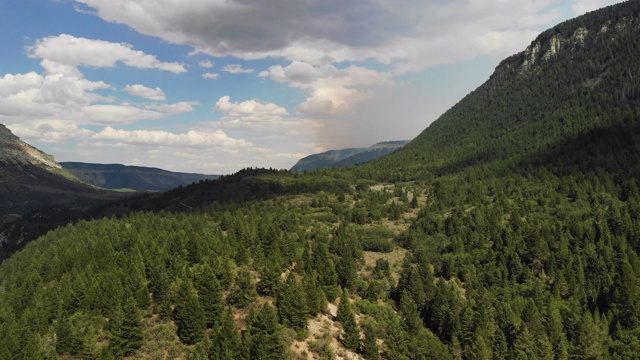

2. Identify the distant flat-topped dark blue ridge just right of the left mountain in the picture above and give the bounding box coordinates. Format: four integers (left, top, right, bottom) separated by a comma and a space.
60, 162, 219, 191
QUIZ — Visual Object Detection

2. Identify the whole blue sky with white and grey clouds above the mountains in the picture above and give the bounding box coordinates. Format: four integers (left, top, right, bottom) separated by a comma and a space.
0, 0, 619, 174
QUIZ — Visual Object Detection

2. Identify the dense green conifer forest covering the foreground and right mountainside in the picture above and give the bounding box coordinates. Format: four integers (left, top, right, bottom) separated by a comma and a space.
0, 1, 640, 359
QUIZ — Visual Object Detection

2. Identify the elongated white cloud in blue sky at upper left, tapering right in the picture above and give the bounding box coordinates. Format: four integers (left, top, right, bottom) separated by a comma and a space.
28, 34, 187, 77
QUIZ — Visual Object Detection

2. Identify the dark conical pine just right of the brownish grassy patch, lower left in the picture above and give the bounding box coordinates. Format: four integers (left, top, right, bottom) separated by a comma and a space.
174, 281, 207, 345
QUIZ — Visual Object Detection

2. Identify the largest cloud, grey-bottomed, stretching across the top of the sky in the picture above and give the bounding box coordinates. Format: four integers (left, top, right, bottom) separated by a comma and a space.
76, 0, 572, 71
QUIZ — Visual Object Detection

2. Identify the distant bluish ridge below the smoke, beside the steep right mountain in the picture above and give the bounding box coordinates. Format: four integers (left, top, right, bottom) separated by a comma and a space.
291, 140, 408, 172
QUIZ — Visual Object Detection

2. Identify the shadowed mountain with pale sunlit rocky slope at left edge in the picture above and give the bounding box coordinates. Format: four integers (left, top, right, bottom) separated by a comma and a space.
0, 124, 123, 260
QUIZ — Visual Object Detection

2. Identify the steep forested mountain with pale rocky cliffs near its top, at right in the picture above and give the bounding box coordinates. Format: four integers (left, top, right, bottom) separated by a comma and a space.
364, 1, 640, 178
